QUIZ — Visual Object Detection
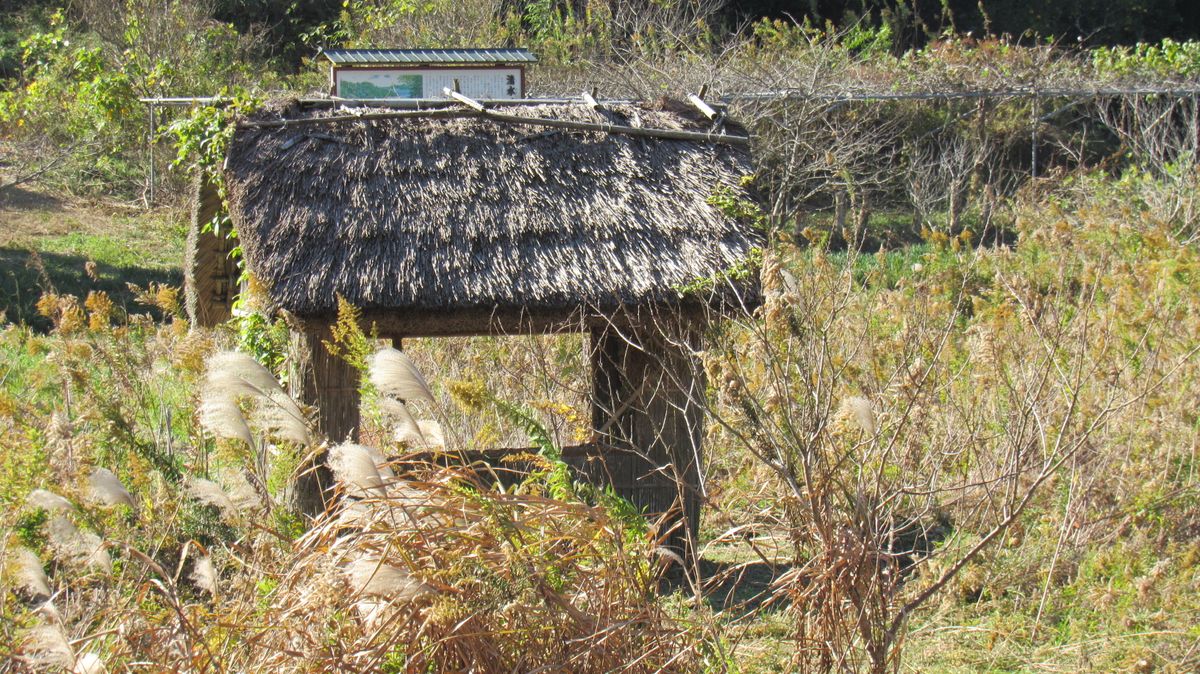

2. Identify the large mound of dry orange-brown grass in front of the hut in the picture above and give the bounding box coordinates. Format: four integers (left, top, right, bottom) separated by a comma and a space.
246, 460, 697, 672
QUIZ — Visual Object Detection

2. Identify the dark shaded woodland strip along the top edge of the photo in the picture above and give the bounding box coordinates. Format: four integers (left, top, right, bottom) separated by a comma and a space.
0, 0, 1200, 78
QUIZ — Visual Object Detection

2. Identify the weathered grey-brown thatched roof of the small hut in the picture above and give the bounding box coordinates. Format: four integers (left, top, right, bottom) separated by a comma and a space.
226, 96, 760, 323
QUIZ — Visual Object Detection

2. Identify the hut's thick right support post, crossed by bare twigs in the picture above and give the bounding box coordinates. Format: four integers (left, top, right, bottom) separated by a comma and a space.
590, 321, 704, 559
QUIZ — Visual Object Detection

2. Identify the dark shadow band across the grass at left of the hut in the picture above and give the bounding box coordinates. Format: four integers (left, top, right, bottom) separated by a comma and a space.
0, 247, 182, 330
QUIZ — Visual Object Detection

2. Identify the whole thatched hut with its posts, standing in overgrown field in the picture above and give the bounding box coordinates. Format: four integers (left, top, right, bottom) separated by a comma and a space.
190, 101, 761, 551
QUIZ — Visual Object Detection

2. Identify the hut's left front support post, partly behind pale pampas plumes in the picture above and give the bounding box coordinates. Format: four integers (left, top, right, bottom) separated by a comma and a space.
293, 324, 359, 517
